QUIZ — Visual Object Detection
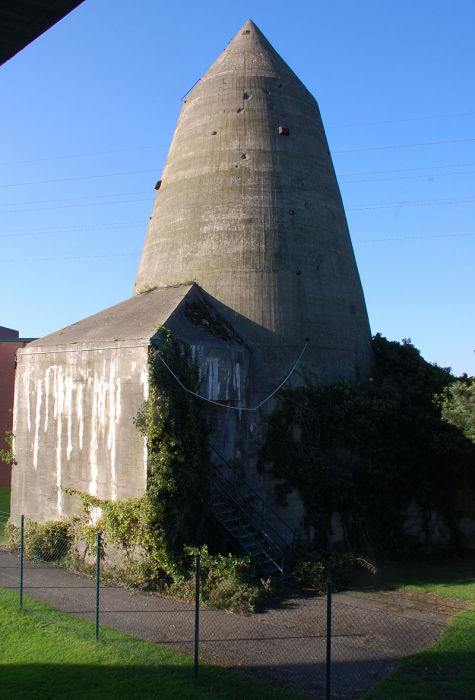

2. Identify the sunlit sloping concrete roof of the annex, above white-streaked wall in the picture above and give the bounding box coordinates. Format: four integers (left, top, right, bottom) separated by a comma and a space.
23, 285, 193, 354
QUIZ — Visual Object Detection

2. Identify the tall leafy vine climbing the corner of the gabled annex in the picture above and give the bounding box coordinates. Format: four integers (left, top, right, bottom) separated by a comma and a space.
135, 327, 211, 551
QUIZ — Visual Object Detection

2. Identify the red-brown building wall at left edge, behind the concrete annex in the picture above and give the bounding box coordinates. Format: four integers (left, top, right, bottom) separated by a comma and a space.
0, 326, 34, 486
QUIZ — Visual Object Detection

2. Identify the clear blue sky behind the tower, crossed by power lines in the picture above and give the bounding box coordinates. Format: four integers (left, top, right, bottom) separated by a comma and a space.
0, 0, 475, 374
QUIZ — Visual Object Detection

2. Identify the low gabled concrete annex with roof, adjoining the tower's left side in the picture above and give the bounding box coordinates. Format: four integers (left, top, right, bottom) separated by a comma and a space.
12, 285, 249, 522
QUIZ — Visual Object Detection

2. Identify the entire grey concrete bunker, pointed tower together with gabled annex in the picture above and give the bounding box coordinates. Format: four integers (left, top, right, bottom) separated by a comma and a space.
12, 21, 371, 528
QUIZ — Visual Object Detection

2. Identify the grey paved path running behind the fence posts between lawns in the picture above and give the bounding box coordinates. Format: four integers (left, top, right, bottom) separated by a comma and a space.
0, 551, 467, 698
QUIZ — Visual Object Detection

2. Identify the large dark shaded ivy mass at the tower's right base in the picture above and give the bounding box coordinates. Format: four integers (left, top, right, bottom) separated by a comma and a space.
259, 335, 475, 551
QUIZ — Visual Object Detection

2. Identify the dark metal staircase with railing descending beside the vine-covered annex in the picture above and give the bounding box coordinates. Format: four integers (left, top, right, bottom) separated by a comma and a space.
211, 448, 304, 578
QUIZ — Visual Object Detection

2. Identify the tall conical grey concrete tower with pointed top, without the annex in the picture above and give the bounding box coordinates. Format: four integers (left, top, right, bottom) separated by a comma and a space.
135, 20, 371, 398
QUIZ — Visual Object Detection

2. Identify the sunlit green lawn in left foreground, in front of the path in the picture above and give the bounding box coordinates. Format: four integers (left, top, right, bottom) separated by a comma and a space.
0, 589, 301, 700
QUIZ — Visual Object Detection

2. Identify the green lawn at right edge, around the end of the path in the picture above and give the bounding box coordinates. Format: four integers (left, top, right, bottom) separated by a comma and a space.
363, 555, 475, 700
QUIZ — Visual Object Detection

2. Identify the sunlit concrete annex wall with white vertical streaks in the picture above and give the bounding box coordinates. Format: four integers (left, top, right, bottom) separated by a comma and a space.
12, 342, 148, 522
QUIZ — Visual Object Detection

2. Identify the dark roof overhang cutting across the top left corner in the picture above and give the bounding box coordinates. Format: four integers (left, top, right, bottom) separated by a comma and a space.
0, 0, 84, 65
